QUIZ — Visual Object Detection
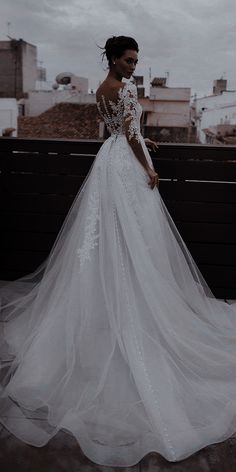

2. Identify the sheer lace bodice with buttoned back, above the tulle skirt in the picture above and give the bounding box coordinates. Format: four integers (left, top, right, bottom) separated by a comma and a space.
97, 82, 142, 142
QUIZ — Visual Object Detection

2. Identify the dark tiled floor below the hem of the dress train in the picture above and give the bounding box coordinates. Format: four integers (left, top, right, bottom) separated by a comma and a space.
0, 300, 236, 472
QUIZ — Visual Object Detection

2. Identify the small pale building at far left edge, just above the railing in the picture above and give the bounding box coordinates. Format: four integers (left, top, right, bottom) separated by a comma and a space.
0, 98, 18, 136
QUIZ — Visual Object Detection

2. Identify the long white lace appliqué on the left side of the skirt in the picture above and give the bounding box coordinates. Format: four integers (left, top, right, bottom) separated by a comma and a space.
76, 184, 100, 272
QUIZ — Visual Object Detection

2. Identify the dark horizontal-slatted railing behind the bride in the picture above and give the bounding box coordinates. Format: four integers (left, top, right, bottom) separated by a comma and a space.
0, 138, 236, 299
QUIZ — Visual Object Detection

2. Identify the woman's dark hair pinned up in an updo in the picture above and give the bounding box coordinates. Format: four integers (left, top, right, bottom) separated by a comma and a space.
102, 36, 139, 66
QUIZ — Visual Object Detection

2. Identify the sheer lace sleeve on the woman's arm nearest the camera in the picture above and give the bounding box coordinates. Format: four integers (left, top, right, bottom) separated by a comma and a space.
124, 84, 149, 169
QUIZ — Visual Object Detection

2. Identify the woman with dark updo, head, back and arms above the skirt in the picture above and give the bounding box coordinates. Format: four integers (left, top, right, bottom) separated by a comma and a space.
96, 36, 159, 189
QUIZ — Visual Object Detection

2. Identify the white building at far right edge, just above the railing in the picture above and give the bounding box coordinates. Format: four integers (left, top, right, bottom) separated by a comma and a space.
193, 79, 236, 143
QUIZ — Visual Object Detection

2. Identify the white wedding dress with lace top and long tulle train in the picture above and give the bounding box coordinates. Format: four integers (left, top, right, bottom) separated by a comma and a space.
0, 83, 236, 466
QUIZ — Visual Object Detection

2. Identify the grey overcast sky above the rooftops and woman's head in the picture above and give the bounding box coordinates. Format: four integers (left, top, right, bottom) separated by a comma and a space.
0, 0, 236, 96
